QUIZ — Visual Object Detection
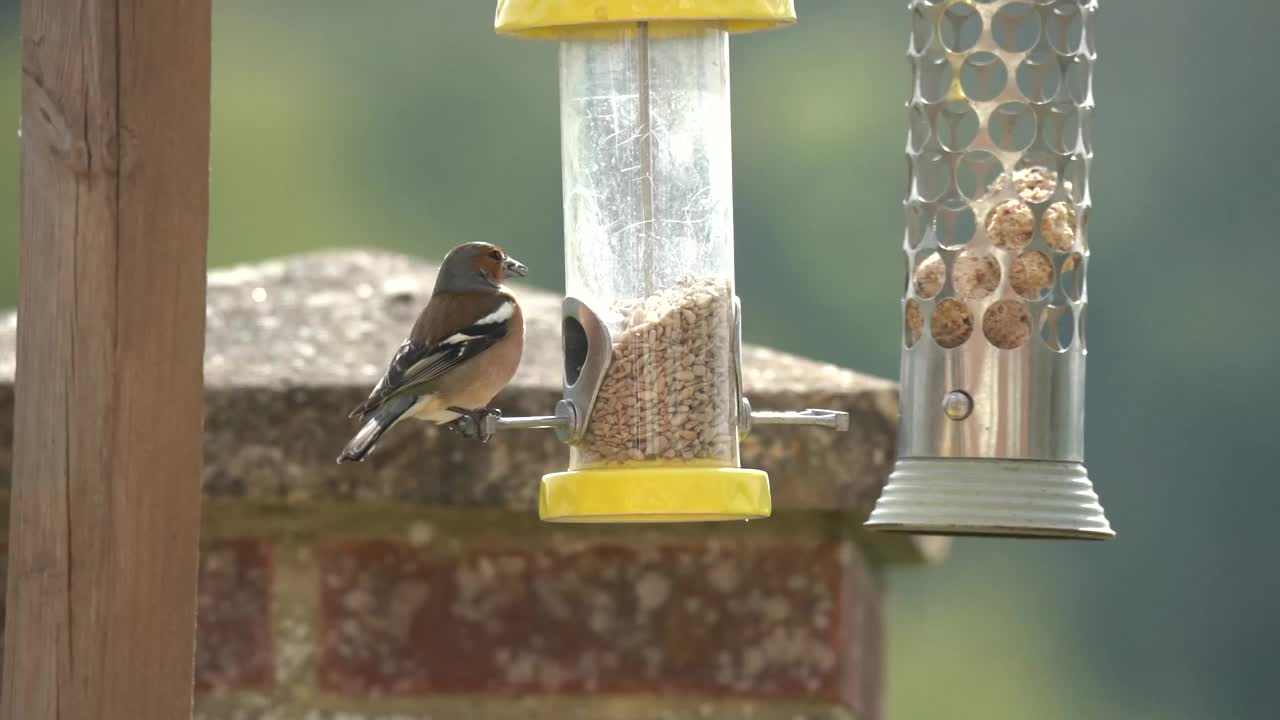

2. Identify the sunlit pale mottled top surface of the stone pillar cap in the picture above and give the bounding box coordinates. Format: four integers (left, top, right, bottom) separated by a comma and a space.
0, 245, 893, 393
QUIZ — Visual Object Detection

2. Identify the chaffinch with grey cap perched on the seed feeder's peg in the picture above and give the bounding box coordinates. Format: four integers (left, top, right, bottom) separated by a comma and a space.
338, 242, 529, 462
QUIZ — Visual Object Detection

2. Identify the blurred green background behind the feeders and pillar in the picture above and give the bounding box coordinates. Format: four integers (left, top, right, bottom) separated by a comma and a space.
0, 0, 1280, 720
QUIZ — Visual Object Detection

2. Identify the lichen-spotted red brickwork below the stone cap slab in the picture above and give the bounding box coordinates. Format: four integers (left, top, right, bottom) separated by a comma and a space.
0, 502, 882, 720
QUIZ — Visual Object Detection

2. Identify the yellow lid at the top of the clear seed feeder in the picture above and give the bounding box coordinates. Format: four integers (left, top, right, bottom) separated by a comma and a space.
493, 0, 796, 40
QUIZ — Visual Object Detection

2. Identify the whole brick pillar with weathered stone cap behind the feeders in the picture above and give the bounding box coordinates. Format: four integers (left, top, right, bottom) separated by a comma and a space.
0, 252, 946, 720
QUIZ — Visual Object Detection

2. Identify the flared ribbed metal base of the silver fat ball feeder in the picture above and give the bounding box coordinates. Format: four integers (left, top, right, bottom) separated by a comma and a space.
867, 457, 1115, 539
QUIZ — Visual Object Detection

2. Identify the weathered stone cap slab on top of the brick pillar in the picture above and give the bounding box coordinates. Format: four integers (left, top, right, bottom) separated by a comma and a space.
0, 251, 946, 560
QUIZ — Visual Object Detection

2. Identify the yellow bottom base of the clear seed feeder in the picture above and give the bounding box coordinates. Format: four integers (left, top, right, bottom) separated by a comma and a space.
538, 465, 773, 523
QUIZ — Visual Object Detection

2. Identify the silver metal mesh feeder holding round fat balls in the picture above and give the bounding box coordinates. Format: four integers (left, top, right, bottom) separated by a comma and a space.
868, 0, 1114, 539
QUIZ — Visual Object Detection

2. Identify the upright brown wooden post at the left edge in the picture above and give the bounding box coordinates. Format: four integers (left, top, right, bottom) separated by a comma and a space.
3, 0, 210, 720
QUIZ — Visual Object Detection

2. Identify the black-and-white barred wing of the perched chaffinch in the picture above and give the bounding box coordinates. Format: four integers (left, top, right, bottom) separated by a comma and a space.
351, 289, 516, 418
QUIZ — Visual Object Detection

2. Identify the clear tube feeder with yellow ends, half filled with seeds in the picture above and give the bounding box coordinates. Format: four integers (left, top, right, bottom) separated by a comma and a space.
490, 0, 847, 523
